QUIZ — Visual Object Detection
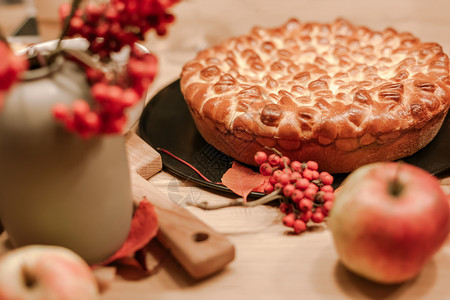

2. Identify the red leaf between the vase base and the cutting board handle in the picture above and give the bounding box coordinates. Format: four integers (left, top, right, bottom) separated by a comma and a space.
102, 199, 158, 265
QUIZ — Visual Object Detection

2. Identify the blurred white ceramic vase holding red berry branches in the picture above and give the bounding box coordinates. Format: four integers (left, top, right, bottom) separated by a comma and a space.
0, 43, 133, 264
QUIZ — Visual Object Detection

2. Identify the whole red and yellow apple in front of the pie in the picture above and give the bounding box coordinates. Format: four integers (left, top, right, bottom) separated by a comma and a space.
329, 162, 450, 283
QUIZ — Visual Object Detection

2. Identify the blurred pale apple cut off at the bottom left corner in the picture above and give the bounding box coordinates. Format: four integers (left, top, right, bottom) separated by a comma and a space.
0, 245, 99, 300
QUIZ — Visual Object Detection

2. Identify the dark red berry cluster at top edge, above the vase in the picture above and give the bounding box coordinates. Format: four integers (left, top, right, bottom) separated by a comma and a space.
59, 0, 178, 58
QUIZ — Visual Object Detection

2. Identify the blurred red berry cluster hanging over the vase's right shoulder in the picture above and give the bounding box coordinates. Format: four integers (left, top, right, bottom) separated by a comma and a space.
53, 46, 157, 138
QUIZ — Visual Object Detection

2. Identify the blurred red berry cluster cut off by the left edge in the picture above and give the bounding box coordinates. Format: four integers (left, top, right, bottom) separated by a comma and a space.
0, 41, 28, 108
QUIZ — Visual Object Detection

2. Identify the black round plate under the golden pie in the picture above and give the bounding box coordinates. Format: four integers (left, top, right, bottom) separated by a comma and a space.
139, 80, 450, 196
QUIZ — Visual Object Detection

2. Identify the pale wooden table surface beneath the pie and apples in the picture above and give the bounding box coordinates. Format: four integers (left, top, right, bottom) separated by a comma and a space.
0, 0, 450, 300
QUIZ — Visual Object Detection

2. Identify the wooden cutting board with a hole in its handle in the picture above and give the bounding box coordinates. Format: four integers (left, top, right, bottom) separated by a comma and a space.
125, 131, 235, 278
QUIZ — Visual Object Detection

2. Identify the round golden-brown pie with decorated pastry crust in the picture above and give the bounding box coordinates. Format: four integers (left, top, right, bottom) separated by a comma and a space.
180, 19, 450, 173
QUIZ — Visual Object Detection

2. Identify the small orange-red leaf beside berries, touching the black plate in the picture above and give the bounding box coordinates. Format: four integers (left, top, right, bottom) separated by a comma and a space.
222, 162, 264, 201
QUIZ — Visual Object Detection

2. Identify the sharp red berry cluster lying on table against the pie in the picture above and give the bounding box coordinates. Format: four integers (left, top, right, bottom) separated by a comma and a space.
254, 151, 334, 233
